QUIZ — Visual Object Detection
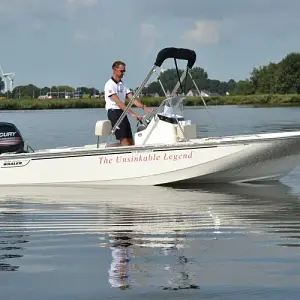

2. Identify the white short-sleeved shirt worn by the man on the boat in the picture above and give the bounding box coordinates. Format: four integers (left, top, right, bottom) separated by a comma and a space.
104, 78, 131, 110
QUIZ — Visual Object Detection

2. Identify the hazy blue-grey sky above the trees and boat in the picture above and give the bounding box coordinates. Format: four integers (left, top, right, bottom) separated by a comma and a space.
0, 0, 300, 91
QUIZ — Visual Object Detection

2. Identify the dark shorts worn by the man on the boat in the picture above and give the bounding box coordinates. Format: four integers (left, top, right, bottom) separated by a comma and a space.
107, 109, 132, 141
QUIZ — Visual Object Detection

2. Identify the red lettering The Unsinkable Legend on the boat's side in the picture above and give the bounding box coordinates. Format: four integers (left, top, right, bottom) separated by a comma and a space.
99, 151, 193, 164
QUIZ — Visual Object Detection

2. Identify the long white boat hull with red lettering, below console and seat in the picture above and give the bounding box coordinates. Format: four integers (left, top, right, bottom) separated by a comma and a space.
0, 133, 300, 185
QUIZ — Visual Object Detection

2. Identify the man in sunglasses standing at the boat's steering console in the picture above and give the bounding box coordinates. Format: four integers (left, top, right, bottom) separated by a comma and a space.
104, 61, 152, 146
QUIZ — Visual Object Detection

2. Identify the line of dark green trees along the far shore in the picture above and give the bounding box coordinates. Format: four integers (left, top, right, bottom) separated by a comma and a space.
0, 52, 300, 98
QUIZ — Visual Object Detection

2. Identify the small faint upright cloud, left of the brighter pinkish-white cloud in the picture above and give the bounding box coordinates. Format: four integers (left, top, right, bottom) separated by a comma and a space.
140, 23, 158, 55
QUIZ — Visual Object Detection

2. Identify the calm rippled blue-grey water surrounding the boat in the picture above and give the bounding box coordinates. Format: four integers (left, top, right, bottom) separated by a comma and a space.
0, 107, 300, 300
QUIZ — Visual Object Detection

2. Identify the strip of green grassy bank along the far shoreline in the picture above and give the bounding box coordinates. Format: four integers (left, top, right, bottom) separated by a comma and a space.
0, 94, 300, 110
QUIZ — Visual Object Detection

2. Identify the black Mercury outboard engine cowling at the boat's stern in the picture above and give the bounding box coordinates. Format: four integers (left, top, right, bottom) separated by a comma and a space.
0, 122, 24, 154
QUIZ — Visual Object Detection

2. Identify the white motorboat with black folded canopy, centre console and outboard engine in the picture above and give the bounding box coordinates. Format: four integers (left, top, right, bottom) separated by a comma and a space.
0, 48, 300, 185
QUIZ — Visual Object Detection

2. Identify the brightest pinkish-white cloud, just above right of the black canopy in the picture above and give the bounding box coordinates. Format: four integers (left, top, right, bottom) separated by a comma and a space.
183, 21, 220, 46
